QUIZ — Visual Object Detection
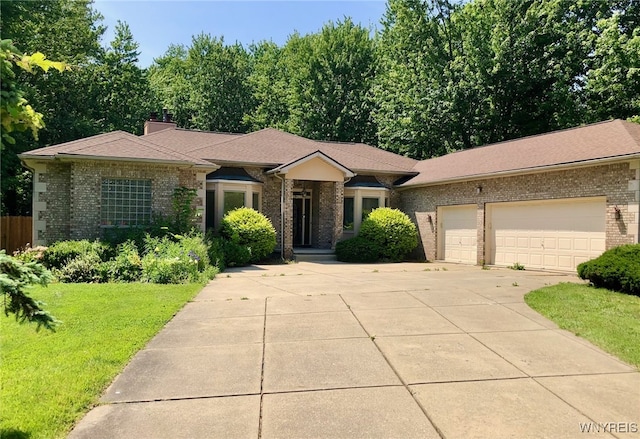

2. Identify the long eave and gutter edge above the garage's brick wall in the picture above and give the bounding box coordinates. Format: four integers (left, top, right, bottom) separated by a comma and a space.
396, 153, 640, 191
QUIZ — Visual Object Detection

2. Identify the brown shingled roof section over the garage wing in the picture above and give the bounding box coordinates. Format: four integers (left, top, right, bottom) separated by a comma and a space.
400, 119, 640, 187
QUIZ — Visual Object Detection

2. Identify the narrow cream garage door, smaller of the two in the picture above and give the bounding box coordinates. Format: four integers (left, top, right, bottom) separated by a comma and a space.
438, 205, 478, 264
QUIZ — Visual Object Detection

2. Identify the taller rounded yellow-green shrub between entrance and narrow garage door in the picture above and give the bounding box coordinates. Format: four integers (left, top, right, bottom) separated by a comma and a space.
358, 207, 418, 261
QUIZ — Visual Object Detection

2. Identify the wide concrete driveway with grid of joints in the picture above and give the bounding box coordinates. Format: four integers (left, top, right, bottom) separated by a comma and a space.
70, 263, 640, 439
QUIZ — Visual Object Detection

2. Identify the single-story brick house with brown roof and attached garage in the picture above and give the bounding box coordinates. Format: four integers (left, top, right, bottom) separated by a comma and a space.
21, 118, 640, 270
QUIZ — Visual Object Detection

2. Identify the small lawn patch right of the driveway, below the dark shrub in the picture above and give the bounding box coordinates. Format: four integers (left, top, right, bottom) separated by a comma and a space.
525, 283, 640, 368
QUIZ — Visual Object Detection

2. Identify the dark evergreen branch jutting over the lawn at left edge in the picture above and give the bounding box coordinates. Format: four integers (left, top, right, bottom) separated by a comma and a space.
0, 250, 59, 330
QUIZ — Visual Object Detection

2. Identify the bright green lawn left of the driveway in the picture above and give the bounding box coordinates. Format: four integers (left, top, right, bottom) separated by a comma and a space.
0, 283, 202, 439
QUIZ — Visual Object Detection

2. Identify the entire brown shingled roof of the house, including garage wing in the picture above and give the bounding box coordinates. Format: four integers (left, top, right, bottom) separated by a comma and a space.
20, 119, 640, 187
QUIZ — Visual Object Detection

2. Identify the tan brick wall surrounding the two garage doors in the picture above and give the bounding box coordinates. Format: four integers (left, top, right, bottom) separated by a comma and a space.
400, 163, 638, 263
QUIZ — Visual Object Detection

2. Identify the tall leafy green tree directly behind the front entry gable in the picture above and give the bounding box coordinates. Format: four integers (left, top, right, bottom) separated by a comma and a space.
285, 18, 375, 143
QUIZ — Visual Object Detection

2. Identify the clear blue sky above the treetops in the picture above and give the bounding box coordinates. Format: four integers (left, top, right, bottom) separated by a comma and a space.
94, 0, 386, 67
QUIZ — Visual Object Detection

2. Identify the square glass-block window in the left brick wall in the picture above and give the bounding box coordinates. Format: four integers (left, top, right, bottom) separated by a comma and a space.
100, 178, 151, 226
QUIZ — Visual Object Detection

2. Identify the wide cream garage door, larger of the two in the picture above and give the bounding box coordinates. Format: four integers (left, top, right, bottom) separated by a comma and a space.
487, 197, 606, 271
